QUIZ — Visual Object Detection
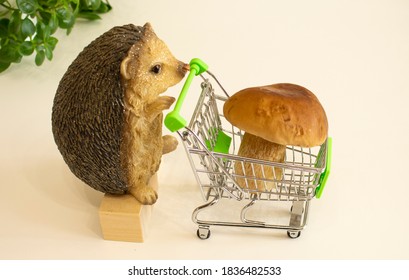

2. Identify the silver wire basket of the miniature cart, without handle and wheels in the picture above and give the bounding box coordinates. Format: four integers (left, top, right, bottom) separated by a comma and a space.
178, 80, 327, 201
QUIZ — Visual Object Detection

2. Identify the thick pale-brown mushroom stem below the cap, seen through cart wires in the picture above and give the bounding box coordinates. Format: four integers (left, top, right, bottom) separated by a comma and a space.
234, 132, 286, 191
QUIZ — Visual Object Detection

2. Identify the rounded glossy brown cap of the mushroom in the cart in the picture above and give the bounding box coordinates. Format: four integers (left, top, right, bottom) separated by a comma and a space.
223, 83, 328, 147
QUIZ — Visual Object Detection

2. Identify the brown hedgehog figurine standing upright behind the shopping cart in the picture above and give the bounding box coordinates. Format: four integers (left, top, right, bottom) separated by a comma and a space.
52, 23, 188, 204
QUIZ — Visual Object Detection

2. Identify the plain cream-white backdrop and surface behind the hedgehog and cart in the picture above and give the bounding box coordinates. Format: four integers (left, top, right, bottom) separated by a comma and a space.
0, 0, 409, 259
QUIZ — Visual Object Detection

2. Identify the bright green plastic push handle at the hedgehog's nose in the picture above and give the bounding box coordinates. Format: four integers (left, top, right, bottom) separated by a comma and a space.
165, 58, 209, 132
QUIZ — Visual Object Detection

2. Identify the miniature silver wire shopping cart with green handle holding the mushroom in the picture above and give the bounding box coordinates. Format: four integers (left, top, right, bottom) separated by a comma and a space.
165, 59, 332, 239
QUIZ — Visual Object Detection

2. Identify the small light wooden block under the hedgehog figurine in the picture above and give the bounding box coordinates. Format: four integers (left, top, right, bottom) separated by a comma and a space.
99, 174, 158, 242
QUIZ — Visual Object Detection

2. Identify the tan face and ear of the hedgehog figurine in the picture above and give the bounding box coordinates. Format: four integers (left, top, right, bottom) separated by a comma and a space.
121, 24, 187, 101
